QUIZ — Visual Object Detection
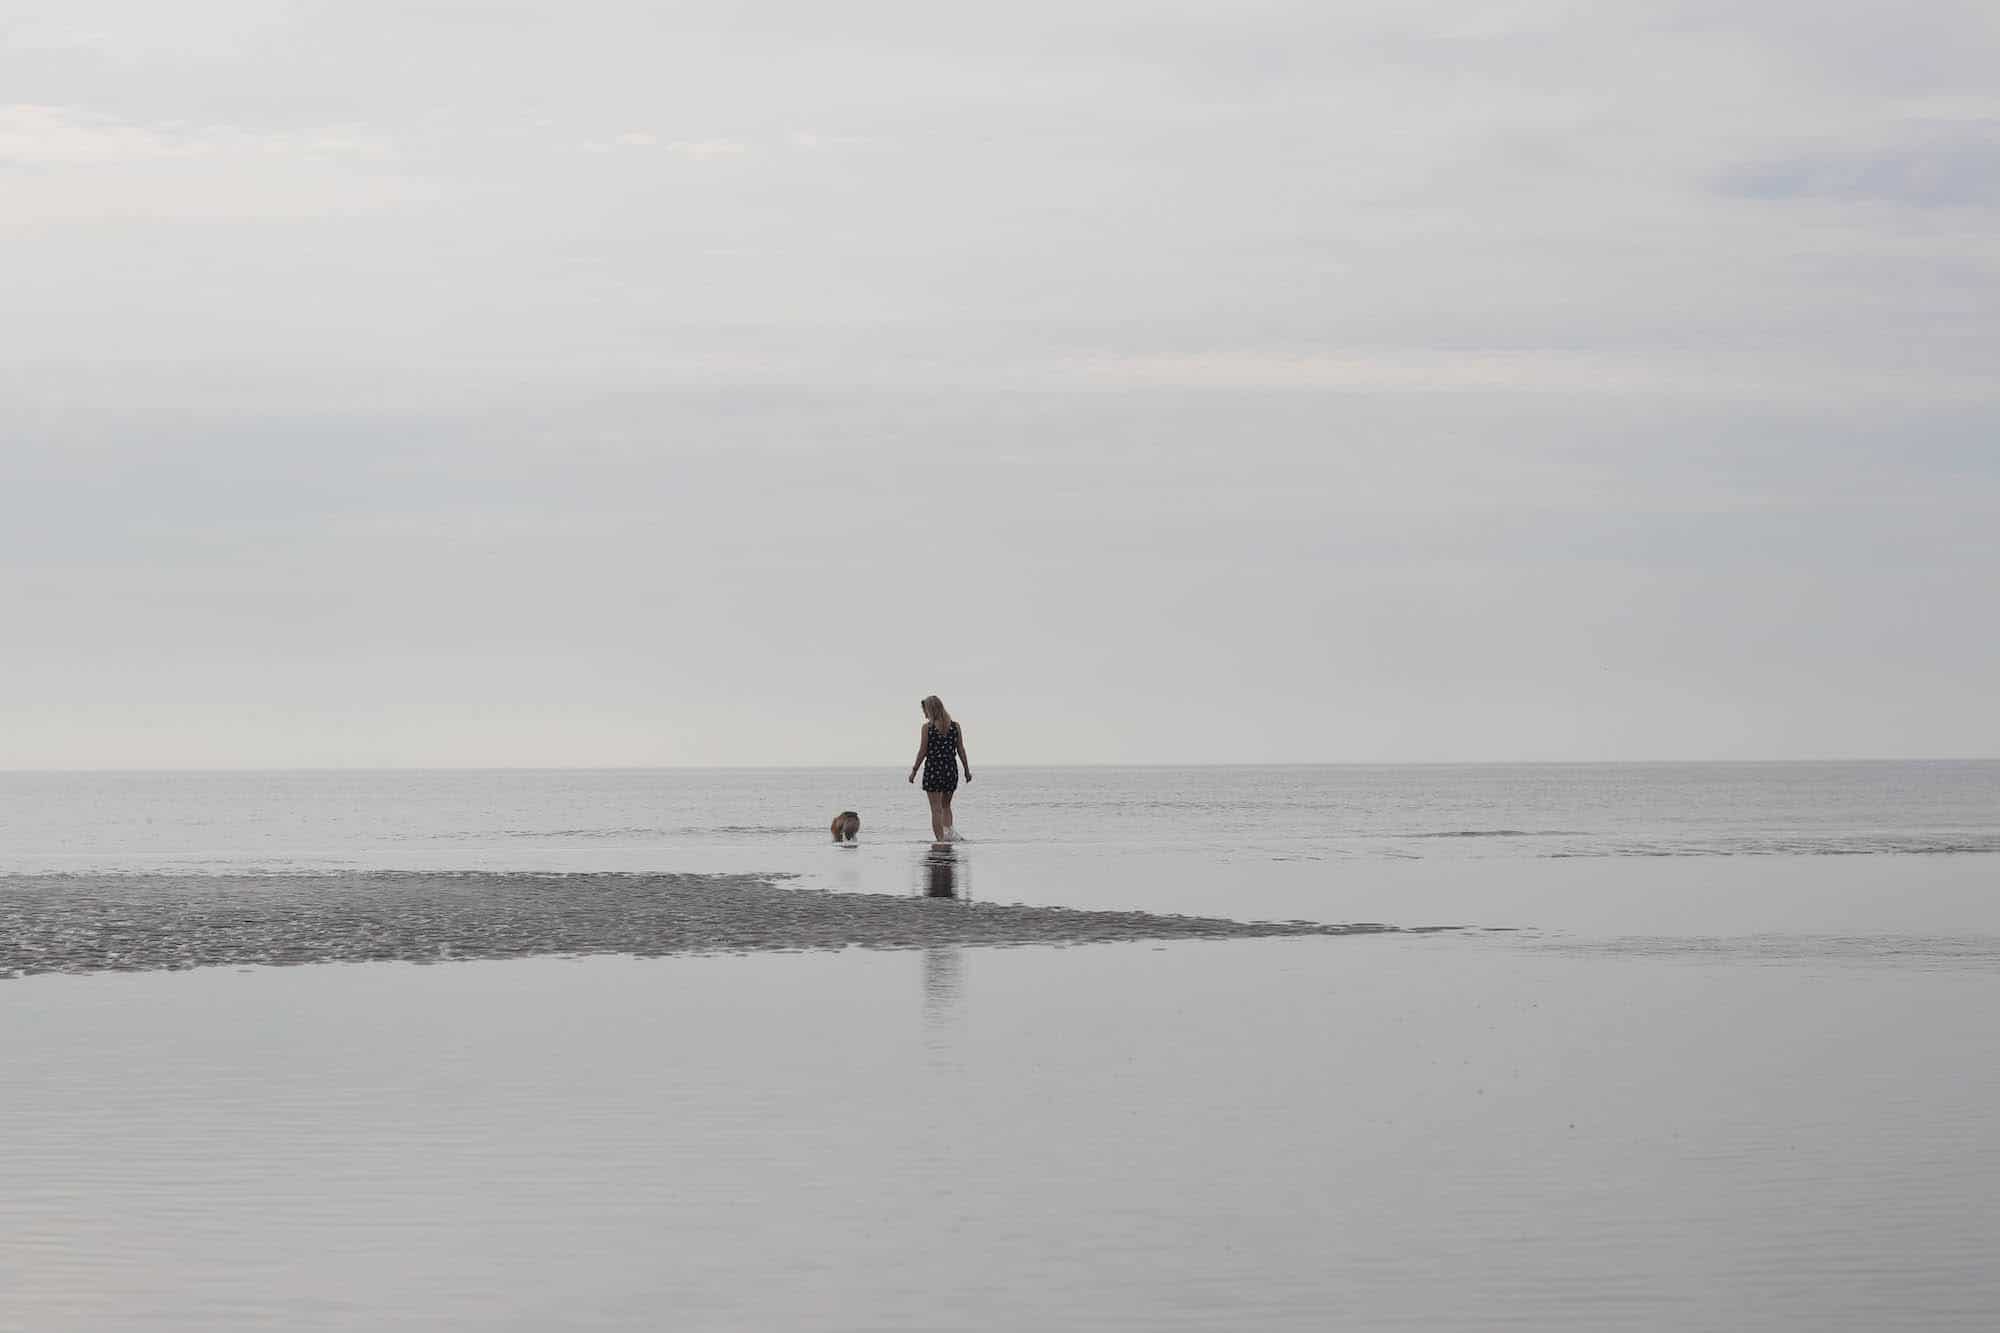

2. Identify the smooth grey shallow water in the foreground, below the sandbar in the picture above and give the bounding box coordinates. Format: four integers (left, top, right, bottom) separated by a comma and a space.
0, 937, 2000, 1331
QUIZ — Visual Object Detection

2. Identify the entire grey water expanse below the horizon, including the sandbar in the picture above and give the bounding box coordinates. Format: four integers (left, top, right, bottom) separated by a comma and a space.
0, 761, 2000, 1331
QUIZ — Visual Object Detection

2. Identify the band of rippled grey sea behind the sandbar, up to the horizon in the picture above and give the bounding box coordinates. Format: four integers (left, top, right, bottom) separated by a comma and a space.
0, 761, 2000, 871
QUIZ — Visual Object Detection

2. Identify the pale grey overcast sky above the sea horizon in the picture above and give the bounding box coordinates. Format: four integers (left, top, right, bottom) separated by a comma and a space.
0, 0, 2000, 769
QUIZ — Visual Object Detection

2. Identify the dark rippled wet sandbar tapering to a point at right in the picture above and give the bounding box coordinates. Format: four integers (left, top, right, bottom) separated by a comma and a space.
0, 873, 1438, 977
